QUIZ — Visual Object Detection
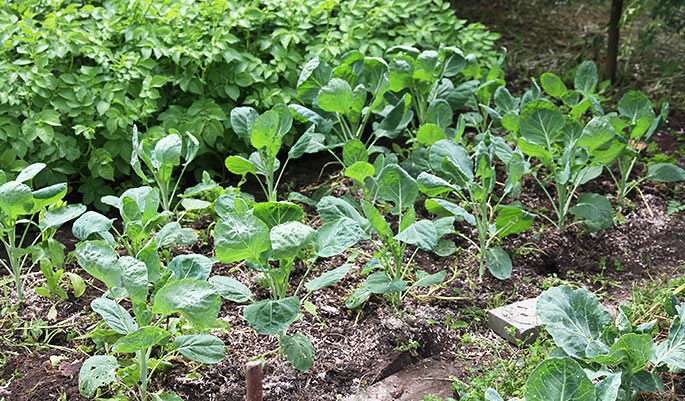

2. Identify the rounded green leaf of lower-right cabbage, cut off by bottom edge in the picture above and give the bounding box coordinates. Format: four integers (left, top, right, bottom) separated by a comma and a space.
525, 358, 596, 401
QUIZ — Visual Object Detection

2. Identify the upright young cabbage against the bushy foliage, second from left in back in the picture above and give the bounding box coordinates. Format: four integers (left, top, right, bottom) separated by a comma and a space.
225, 104, 323, 202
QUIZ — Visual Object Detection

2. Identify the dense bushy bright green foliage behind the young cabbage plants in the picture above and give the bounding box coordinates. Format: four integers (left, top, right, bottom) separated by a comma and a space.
0, 0, 497, 203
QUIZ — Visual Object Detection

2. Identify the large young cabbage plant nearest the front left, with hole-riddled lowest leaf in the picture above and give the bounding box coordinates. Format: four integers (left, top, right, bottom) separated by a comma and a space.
75, 240, 226, 401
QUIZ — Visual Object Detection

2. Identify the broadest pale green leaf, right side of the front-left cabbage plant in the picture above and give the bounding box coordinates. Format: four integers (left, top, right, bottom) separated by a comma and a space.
152, 278, 221, 327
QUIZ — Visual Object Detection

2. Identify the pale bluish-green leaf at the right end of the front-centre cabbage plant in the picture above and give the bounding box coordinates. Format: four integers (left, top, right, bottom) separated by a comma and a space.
312, 217, 365, 258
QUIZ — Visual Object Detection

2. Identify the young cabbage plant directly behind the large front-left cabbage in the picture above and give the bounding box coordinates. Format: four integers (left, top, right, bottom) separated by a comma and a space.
72, 187, 197, 257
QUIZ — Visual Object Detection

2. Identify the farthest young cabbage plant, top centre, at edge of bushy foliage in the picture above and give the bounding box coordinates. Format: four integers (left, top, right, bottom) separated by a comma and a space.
387, 46, 476, 129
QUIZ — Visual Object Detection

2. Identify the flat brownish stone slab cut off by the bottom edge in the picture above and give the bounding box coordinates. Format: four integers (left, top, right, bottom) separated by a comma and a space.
343, 358, 458, 401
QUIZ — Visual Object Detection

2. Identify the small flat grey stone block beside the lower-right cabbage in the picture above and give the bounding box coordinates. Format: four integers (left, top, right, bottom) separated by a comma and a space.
488, 298, 542, 344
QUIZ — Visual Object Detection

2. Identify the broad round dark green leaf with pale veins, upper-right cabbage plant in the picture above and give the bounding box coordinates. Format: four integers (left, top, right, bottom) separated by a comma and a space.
519, 99, 565, 150
